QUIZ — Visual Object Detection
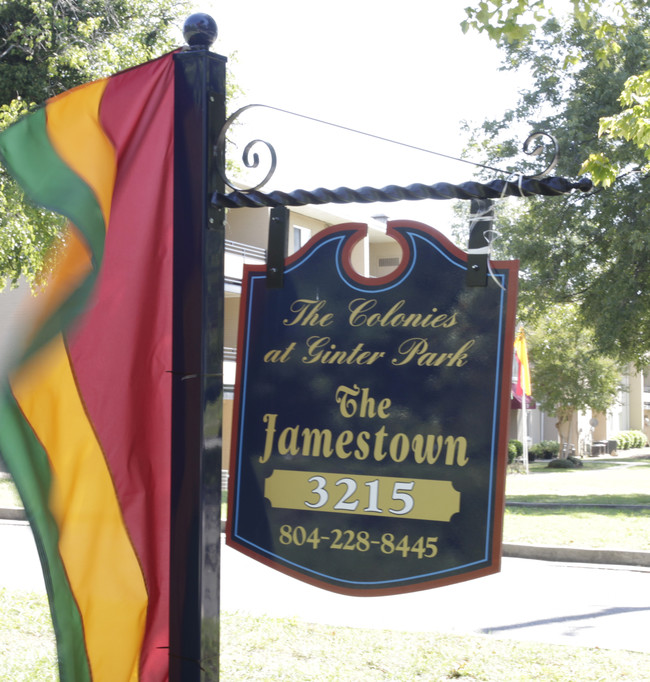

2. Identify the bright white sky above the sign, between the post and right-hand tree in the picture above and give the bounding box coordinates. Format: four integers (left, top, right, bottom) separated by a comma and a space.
186, 0, 523, 232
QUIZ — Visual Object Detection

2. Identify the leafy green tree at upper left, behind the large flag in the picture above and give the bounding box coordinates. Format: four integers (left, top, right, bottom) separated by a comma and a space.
0, 0, 188, 282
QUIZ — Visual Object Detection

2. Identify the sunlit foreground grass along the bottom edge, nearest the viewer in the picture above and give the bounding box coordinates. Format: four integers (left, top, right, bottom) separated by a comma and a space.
0, 589, 650, 682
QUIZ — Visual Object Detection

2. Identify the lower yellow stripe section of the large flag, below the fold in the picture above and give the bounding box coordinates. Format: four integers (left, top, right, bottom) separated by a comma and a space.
11, 336, 147, 681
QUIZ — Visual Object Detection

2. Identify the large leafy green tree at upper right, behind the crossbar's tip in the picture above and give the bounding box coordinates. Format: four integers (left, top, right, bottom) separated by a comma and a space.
458, 2, 650, 366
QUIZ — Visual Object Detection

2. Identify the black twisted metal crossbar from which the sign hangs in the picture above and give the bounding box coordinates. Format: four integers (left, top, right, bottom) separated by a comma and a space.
212, 177, 593, 208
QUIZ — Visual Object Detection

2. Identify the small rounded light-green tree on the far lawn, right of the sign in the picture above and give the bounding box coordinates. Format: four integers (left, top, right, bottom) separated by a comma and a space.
527, 304, 620, 452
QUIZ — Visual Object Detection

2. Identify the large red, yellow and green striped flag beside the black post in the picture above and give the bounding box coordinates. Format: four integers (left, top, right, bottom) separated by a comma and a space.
0, 54, 174, 682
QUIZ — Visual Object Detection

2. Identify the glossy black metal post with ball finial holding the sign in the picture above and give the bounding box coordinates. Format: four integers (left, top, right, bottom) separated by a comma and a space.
169, 14, 226, 682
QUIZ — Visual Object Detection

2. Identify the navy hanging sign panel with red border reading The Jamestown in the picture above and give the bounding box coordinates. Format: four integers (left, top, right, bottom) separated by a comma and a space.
227, 221, 517, 595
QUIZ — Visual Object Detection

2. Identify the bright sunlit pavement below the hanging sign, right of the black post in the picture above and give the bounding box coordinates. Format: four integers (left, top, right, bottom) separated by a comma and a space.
221, 547, 650, 652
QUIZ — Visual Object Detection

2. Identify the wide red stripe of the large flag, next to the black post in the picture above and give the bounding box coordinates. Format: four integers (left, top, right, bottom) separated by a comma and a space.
69, 55, 174, 682
